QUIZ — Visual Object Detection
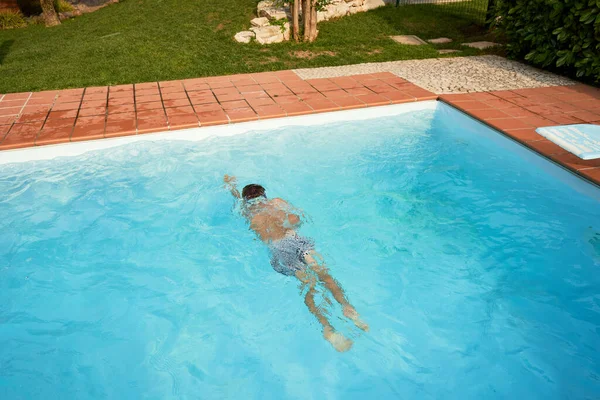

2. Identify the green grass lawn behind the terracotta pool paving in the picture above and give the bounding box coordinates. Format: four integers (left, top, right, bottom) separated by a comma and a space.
0, 0, 500, 93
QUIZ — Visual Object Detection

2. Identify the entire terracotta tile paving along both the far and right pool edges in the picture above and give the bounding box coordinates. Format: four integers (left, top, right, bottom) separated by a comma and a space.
0, 71, 600, 185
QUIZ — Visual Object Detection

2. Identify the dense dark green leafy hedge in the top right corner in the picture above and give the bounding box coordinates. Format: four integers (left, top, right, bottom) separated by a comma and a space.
495, 0, 600, 82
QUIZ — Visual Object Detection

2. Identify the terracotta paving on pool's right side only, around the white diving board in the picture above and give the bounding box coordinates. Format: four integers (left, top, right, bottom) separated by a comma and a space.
439, 84, 600, 185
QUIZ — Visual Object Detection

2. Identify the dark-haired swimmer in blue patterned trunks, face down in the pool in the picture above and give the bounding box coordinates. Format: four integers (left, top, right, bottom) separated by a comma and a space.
224, 175, 369, 351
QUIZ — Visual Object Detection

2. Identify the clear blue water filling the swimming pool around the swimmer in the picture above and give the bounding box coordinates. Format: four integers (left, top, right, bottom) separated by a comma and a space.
0, 106, 600, 399
